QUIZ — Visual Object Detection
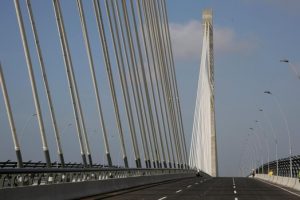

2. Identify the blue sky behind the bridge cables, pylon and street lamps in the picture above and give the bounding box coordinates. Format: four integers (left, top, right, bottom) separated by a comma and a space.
0, 0, 300, 176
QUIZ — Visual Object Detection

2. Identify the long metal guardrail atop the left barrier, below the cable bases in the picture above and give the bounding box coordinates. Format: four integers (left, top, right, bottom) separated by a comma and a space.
0, 168, 196, 189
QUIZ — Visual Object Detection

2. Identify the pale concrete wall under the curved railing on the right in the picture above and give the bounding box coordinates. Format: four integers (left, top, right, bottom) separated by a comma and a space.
255, 174, 300, 191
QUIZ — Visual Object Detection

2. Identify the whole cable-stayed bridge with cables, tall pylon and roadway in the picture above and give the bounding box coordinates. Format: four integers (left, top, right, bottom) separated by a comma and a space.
0, 0, 297, 200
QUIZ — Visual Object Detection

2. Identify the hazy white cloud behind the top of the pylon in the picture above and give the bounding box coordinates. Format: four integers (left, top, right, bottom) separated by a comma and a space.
170, 20, 256, 60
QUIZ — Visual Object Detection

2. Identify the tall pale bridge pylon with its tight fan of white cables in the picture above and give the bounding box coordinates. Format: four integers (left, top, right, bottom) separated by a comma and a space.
190, 9, 218, 176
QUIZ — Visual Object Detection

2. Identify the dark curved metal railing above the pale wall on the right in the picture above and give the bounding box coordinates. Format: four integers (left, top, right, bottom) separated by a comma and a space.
255, 155, 300, 177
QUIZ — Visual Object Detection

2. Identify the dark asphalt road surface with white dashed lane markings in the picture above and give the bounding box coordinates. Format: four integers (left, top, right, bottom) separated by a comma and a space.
88, 177, 300, 200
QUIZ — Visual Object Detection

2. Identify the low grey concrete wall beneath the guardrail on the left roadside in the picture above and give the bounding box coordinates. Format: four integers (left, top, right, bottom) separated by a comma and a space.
0, 173, 195, 200
